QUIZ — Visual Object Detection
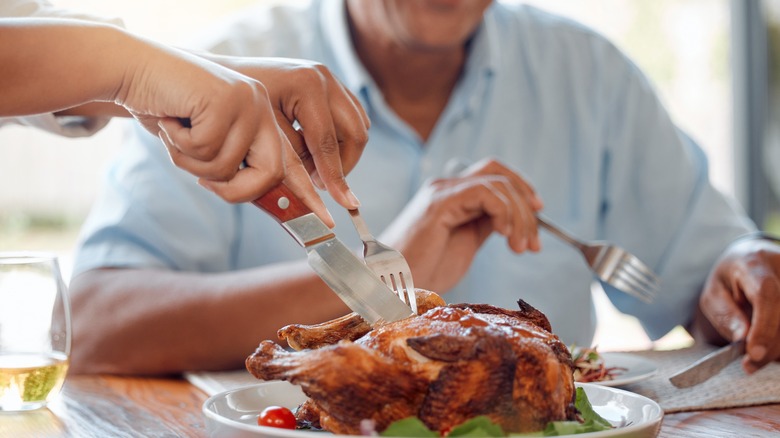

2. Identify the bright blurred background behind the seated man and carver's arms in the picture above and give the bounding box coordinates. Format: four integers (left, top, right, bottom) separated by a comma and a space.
0, 0, 780, 348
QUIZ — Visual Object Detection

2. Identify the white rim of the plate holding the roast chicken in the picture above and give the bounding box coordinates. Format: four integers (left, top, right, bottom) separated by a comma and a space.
202, 381, 664, 438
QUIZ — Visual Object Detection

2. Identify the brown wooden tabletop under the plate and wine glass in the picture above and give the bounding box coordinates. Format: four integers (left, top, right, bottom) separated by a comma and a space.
0, 376, 780, 438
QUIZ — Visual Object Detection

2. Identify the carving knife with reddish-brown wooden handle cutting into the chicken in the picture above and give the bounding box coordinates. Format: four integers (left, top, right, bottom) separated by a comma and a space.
252, 183, 412, 326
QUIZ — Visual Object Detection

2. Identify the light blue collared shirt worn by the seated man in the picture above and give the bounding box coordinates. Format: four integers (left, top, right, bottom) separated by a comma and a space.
74, 0, 753, 345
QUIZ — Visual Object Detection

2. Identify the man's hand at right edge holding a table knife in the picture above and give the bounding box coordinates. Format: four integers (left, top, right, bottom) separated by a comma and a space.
699, 239, 780, 373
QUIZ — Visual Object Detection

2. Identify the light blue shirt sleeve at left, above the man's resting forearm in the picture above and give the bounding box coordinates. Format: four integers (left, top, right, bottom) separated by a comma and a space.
73, 125, 238, 276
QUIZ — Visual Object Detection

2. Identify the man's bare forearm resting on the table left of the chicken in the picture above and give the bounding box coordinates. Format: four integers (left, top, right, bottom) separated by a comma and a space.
71, 263, 349, 374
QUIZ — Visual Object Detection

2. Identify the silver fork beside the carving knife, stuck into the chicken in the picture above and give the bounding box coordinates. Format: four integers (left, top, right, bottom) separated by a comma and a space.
349, 208, 417, 315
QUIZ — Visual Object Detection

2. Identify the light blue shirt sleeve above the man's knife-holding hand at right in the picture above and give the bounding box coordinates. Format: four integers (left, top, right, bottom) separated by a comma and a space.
599, 46, 755, 339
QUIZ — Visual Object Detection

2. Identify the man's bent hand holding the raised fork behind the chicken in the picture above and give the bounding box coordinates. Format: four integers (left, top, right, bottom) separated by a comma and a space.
379, 160, 542, 292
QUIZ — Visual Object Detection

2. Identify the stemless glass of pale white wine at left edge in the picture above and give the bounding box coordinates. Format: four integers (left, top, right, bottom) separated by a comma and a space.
0, 252, 70, 411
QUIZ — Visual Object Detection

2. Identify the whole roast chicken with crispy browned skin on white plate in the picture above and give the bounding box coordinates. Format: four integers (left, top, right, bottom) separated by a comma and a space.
246, 290, 575, 434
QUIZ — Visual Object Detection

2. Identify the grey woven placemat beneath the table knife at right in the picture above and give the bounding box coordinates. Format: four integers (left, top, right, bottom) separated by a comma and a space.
622, 345, 780, 414
